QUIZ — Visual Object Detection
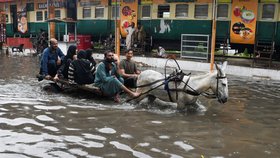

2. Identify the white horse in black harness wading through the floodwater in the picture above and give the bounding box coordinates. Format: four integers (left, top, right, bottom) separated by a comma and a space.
136, 62, 228, 111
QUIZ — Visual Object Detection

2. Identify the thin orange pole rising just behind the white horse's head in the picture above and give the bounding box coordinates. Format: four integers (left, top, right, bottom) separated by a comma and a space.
210, 0, 217, 72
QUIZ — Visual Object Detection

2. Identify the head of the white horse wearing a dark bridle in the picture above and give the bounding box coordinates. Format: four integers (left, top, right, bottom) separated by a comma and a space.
212, 61, 228, 103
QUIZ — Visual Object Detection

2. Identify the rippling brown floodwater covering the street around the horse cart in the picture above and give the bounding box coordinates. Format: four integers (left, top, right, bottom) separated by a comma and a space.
0, 54, 280, 158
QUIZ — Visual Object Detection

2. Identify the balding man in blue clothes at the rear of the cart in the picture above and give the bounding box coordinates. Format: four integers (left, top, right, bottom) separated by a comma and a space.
38, 38, 64, 81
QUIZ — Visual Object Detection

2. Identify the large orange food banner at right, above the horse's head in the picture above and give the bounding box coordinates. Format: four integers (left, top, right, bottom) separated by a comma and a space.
230, 0, 258, 44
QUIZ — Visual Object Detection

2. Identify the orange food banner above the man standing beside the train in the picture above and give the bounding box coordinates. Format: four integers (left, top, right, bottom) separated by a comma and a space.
120, 0, 138, 37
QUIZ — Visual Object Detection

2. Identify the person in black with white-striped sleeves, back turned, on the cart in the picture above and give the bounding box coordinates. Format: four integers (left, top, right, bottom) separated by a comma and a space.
68, 50, 95, 84
